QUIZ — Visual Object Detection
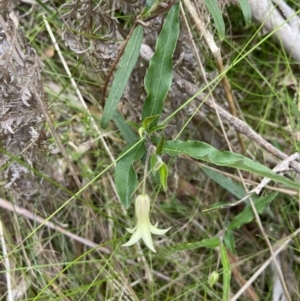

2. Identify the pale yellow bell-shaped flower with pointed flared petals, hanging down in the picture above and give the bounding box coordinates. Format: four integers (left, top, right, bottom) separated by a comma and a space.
123, 194, 171, 253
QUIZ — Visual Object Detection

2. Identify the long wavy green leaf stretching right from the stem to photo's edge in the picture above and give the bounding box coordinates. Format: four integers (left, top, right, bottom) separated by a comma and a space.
164, 140, 300, 189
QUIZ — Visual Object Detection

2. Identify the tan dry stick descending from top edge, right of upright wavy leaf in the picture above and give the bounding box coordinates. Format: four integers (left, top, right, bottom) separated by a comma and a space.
184, 0, 246, 154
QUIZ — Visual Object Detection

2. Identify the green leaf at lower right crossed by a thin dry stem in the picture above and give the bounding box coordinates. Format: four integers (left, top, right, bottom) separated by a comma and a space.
227, 192, 278, 230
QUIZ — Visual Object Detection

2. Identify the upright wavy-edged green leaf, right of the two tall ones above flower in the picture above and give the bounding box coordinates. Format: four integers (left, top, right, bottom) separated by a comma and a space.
142, 2, 179, 126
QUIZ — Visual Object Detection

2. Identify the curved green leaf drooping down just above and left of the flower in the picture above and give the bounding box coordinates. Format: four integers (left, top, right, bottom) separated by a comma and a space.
115, 142, 146, 208
